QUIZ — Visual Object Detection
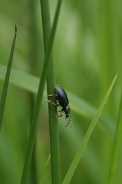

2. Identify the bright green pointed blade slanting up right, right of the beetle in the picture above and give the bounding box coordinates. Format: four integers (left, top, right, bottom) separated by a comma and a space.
63, 76, 117, 184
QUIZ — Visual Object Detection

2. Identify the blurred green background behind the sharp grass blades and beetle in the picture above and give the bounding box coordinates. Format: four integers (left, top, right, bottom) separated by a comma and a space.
0, 0, 122, 184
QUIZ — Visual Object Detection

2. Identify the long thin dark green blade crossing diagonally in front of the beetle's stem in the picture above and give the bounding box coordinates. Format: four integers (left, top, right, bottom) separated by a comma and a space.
21, 0, 61, 184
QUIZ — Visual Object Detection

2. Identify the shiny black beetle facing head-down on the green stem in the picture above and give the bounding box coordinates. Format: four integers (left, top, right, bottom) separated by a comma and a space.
47, 85, 71, 127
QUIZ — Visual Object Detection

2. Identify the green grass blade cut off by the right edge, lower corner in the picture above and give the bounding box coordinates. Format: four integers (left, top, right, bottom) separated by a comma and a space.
108, 93, 122, 184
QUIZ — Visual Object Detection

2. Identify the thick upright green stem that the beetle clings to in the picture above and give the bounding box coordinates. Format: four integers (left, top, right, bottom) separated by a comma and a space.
40, 0, 62, 184
